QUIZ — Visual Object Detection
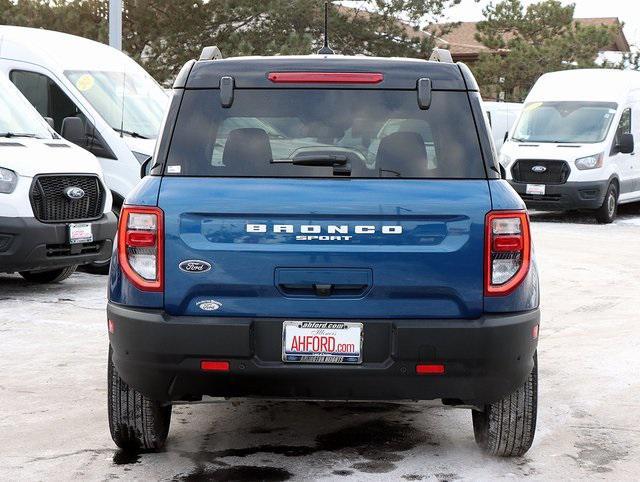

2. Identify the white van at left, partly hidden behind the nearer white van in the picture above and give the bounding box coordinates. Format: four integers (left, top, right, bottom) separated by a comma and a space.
0, 26, 169, 212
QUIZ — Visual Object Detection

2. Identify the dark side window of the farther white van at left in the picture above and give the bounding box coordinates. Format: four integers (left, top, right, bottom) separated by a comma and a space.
9, 70, 87, 133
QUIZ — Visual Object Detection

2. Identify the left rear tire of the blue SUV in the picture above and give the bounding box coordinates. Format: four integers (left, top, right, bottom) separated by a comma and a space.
107, 346, 171, 451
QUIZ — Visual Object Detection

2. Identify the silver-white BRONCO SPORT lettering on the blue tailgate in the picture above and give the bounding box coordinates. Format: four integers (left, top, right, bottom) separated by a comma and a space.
246, 224, 402, 241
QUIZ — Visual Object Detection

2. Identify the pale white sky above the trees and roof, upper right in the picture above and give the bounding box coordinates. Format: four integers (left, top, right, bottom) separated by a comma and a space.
446, 0, 640, 47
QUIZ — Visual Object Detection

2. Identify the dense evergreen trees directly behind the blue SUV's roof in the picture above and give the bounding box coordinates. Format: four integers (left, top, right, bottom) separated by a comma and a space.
0, 0, 460, 84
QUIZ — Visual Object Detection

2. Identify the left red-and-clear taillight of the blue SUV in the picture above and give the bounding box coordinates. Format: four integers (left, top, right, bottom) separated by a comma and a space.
118, 206, 164, 291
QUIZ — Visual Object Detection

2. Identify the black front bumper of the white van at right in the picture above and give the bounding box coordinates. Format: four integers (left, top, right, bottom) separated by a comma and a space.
509, 179, 609, 211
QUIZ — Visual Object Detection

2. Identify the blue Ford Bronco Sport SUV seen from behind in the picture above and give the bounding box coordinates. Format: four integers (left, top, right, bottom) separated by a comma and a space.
107, 49, 540, 456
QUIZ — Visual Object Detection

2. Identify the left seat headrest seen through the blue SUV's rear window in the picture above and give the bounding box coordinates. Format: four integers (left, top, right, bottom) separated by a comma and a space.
222, 128, 273, 169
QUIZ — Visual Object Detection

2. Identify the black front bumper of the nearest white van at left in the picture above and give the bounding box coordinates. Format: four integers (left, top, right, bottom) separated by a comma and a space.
0, 212, 116, 273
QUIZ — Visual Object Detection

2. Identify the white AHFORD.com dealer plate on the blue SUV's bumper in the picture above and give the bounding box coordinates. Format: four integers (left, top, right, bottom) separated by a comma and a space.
282, 321, 362, 363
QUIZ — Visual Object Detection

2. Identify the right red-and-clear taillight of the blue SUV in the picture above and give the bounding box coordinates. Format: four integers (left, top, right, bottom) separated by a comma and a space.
484, 211, 531, 296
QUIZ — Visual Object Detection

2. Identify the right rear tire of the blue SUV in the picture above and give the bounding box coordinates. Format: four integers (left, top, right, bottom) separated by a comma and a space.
472, 353, 538, 457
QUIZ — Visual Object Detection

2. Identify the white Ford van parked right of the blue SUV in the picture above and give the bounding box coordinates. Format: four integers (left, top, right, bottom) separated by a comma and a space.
500, 69, 640, 223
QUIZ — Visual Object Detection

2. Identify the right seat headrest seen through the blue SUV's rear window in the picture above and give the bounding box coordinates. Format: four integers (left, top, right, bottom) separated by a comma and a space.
376, 132, 430, 177
